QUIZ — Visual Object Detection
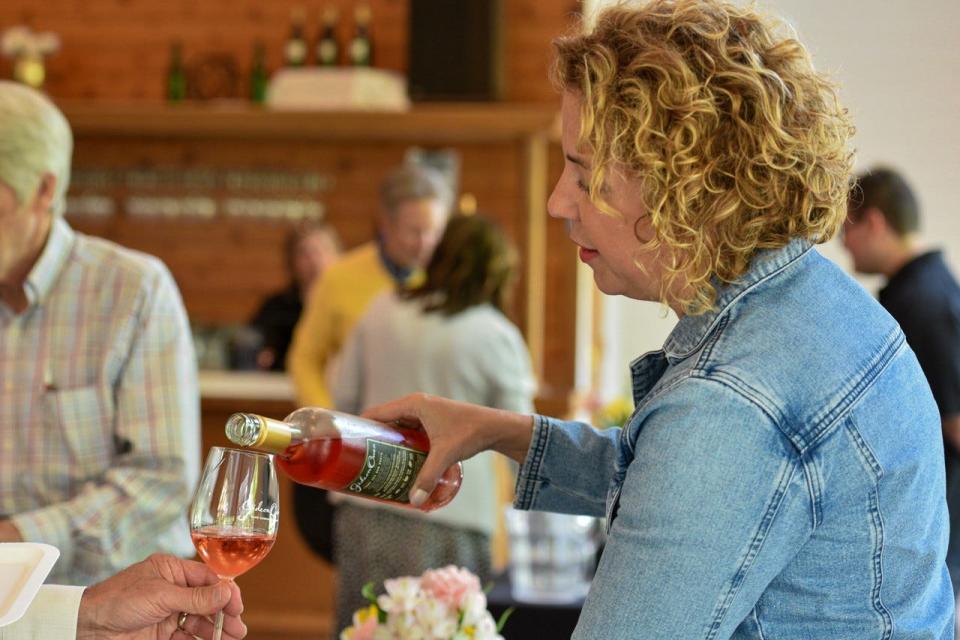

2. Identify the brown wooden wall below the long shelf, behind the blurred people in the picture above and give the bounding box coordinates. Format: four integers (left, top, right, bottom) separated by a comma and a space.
70, 131, 526, 325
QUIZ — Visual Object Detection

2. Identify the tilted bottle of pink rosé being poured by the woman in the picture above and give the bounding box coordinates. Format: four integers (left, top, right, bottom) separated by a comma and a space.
226, 407, 463, 511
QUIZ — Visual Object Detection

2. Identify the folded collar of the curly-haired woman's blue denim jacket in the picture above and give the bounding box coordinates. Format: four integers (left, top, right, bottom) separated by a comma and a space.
664, 238, 812, 362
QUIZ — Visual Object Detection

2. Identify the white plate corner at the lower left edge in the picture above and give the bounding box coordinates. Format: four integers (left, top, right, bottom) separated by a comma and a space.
0, 542, 60, 627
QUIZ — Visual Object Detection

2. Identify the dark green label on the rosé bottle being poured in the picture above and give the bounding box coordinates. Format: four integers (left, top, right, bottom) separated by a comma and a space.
347, 438, 427, 503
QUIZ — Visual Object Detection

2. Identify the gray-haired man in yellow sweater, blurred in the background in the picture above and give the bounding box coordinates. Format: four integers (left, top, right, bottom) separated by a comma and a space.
287, 164, 453, 560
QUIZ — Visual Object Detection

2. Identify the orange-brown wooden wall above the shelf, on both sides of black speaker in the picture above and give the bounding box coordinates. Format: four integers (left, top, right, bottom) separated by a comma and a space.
0, 0, 579, 102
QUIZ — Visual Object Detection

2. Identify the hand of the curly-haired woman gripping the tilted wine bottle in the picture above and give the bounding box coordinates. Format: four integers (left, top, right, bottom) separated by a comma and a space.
363, 393, 533, 507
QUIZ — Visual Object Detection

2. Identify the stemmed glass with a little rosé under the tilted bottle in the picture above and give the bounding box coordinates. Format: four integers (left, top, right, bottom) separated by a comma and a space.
190, 447, 280, 640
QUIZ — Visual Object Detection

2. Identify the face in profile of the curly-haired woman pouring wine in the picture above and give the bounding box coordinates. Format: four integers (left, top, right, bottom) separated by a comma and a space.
547, 91, 662, 300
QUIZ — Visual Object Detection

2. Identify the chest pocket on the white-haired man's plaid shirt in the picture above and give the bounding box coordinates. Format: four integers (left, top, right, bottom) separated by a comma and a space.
43, 386, 114, 480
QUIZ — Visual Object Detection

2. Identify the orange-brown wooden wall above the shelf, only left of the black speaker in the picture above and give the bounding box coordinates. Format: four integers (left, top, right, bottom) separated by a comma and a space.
0, 0, 407, 100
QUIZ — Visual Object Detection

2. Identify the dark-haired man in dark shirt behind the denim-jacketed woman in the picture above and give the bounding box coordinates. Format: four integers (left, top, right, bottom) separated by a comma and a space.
843, 169, 960, 593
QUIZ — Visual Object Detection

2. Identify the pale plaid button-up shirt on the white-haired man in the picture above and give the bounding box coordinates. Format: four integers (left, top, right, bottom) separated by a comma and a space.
0, 218, 200, 584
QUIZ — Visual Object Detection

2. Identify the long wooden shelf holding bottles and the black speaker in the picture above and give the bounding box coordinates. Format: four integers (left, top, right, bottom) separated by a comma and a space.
59, 101, 557, 144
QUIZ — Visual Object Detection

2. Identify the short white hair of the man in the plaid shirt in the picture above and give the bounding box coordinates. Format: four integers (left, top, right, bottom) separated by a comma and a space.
0, 80, 73, 215
